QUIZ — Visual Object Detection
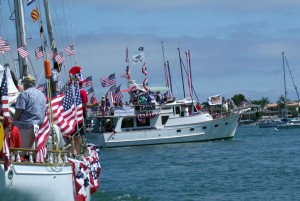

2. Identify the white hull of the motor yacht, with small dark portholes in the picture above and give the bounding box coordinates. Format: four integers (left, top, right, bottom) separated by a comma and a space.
86, 115, 240, 148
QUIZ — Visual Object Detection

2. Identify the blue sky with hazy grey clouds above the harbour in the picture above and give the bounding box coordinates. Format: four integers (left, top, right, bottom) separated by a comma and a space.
0, 0, 300, 102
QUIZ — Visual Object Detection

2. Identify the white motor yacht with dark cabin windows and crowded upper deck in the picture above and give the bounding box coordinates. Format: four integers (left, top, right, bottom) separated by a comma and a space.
86, 81, 241, 147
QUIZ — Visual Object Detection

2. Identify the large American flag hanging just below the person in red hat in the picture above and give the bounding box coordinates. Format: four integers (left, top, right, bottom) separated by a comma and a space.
52, 83, 83, 135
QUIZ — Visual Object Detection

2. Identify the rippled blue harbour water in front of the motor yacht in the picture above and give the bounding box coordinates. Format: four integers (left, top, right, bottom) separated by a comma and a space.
92, 127, 300, 201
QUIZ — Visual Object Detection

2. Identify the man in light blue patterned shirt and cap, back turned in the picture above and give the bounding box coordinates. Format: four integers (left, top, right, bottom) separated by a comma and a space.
13, 75, 46, 148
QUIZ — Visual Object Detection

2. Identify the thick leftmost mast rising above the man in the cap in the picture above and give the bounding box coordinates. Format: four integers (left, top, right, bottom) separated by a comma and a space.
14, 0, 28, 79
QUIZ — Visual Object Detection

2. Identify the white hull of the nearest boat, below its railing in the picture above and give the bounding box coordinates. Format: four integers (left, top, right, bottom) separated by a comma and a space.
0, 162, 81, 201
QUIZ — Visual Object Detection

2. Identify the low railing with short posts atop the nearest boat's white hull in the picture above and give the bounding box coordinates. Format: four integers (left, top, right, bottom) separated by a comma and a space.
5, 148, 70, 164
